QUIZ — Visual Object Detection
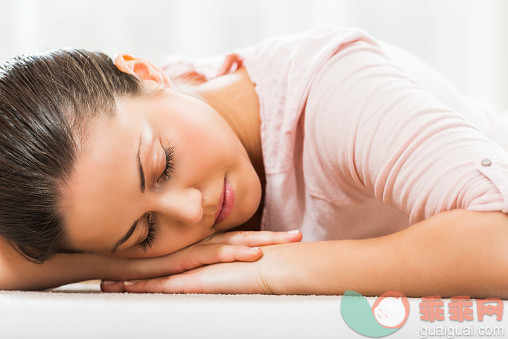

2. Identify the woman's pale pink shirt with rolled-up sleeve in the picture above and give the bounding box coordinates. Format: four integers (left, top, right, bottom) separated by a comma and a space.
163, 26, 508, 241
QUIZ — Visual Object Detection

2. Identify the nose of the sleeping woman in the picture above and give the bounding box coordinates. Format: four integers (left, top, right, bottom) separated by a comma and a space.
156, 187, 203, 226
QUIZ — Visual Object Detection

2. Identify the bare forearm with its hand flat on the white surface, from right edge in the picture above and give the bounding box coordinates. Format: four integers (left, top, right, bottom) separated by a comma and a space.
94, 55, 508, 298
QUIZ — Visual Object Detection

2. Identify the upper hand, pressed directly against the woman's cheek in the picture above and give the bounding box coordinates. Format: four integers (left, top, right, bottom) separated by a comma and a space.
101, 231, 302, 292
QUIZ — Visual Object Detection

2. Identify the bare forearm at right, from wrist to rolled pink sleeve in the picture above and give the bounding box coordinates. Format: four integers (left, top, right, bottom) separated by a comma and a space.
263, 210, 508, 298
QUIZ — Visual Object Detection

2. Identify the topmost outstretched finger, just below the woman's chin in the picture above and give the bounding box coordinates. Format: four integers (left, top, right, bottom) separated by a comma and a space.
201, 230, 302, 246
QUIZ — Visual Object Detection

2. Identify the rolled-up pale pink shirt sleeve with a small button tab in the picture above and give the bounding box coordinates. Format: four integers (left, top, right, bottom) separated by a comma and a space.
306, 41, 508, 224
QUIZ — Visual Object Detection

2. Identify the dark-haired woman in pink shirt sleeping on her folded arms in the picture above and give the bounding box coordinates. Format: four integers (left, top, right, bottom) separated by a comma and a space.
0, 26, 508, 297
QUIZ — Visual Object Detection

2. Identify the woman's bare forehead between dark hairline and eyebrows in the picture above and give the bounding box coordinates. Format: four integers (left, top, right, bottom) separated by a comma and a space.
61, 101, 143, 250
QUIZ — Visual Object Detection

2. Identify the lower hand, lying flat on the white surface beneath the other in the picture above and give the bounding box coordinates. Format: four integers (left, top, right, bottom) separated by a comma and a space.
102, 243, 304, 294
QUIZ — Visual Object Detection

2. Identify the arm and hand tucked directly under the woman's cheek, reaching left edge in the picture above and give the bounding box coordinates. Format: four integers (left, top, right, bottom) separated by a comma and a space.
0, 231, 301, 290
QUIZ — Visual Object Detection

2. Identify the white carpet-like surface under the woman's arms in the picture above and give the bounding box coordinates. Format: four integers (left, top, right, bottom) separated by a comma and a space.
0, 280, 508, 339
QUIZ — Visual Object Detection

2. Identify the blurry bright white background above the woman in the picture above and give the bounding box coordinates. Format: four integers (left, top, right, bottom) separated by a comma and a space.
0, 0, 508, 111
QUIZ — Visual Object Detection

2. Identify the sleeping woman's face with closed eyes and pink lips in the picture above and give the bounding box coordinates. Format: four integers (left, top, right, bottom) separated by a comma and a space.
62, 89, 261, 257
